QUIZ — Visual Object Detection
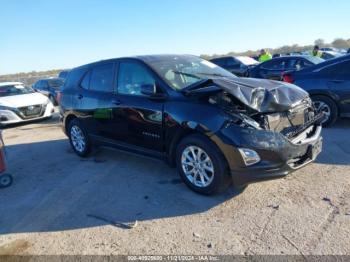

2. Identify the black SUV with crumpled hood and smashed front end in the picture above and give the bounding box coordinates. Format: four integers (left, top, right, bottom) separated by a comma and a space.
60, 55, 322, 194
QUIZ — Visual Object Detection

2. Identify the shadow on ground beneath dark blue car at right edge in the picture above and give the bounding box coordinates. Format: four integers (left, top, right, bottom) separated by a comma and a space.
315, 119, 350, 165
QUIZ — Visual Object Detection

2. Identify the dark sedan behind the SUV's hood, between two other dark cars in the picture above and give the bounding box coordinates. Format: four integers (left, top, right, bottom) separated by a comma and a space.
249, 56, 324, 81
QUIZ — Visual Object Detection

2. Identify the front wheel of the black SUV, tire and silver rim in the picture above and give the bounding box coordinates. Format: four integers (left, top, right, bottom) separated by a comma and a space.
176, 135, 231, 195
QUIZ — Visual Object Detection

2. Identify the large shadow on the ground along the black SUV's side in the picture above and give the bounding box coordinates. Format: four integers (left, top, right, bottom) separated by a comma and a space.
0, 139, 241, 234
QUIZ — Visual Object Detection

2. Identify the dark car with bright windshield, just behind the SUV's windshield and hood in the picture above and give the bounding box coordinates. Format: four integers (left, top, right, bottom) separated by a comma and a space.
210, 56, 259, 76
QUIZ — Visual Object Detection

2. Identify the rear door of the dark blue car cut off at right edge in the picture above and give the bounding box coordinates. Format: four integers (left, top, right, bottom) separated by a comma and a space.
320, 60, 350, 116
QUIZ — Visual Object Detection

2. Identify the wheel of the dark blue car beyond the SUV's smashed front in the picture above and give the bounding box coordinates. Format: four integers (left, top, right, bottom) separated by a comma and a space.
311, 95, 338, 127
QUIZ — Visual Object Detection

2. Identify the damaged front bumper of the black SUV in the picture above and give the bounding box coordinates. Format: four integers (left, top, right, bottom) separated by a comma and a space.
219, 125, 323, 186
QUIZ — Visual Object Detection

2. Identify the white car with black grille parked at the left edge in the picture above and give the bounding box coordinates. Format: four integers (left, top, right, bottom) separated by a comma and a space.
0, 82, 55, 125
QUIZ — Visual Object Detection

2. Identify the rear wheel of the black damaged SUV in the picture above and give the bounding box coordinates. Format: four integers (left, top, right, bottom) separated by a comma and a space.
68, 118, 92, 157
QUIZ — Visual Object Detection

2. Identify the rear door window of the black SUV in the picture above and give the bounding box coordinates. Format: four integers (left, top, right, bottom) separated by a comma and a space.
89, 63, 114, 92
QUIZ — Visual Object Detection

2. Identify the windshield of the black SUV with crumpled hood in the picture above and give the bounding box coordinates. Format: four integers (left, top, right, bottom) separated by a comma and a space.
148, 56, 236, 90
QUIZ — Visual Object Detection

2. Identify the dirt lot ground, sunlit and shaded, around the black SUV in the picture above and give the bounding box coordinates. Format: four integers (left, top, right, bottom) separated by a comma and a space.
0, 113, 350, 255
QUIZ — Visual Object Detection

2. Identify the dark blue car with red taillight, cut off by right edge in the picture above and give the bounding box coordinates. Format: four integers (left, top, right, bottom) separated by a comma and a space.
283, 55, 350, 126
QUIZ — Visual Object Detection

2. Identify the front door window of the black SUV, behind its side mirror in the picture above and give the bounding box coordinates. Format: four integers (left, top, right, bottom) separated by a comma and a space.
118, 62, 155, 96
